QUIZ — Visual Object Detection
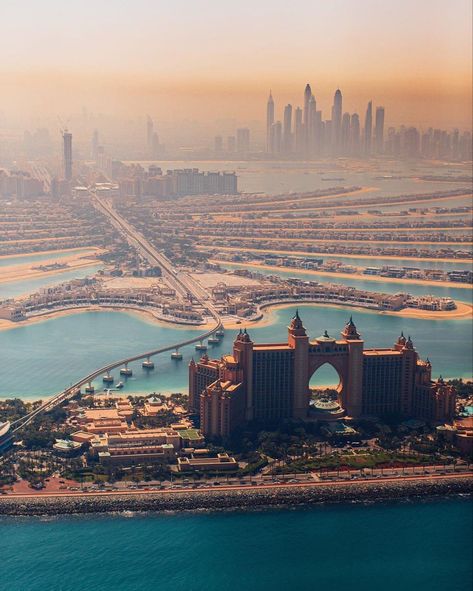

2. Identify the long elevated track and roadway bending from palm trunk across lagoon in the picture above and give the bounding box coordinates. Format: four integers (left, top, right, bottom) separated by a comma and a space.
11, 193, 223, 433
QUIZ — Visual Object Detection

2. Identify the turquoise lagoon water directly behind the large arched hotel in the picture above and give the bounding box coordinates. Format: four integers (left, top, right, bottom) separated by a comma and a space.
0, 306, 473, 398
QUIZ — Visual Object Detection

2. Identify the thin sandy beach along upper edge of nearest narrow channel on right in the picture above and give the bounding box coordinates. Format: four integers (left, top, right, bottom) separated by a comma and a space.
215, 259, 472, 290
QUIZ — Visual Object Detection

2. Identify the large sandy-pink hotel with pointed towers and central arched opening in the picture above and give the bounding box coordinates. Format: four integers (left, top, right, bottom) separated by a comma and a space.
189, 312, 455, 437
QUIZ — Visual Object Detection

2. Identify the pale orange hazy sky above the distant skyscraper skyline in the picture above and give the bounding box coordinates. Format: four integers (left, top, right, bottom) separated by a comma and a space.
0, 0, 472, 127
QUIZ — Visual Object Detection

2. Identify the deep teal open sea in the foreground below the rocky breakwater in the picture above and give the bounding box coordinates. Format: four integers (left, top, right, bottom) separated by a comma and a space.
0, 500, 473, 591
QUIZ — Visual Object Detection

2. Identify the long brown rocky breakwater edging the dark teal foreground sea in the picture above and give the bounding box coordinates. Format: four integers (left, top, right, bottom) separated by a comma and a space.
0, 476, 473, 516
